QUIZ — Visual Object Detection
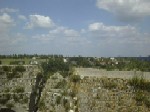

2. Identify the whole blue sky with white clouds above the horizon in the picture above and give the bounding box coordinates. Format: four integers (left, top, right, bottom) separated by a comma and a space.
0, 0, 150, 57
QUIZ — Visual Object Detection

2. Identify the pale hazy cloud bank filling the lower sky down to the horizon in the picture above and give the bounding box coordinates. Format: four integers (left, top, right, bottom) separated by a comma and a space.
0, 7, 150, 56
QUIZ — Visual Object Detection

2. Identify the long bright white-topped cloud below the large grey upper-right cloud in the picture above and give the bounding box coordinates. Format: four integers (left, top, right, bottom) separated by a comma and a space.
89, 22, 138, 39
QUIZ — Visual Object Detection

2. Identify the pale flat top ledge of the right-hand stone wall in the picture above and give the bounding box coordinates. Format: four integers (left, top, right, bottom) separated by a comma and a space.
75, 68, 150, 80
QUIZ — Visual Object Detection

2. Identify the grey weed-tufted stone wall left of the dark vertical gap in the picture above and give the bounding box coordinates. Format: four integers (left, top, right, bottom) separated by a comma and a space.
0, 65, 39, 112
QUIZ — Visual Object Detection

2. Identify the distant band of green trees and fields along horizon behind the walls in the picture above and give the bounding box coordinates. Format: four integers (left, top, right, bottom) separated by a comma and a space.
0, 54, 150, 72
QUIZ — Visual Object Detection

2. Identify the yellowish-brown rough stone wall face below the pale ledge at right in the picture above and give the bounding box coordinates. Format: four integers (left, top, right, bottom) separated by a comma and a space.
77, 77, 150, 112
